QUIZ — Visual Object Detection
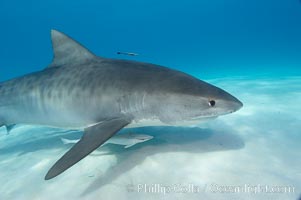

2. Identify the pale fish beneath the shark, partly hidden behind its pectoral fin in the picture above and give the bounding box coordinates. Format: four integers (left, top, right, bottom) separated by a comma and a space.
61, 133, 154, 149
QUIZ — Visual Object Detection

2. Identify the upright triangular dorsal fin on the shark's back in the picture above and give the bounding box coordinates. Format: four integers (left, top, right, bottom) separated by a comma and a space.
48, 30, 96, 67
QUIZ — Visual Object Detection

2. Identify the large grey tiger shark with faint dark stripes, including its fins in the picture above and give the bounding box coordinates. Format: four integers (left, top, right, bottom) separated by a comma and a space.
0, 30, 243, 180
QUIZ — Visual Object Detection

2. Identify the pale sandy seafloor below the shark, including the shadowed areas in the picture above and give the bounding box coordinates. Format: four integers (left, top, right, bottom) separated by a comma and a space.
0, 77, 301, 200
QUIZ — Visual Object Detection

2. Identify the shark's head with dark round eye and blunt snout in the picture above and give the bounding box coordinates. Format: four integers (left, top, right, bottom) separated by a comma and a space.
146, 69, 243, 124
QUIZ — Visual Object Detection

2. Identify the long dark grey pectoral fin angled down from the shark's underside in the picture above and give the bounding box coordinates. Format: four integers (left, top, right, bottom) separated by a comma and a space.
45, 118, 130, 180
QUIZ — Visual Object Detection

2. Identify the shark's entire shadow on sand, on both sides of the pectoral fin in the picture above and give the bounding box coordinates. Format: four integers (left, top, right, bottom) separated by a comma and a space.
0, 126, 244, 196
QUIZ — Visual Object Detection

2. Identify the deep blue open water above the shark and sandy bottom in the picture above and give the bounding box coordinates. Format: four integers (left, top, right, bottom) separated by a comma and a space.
0, 0, 301, 80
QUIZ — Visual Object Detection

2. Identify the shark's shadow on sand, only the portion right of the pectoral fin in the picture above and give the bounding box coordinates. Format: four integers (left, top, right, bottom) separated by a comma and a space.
82, 127, 244, 196
